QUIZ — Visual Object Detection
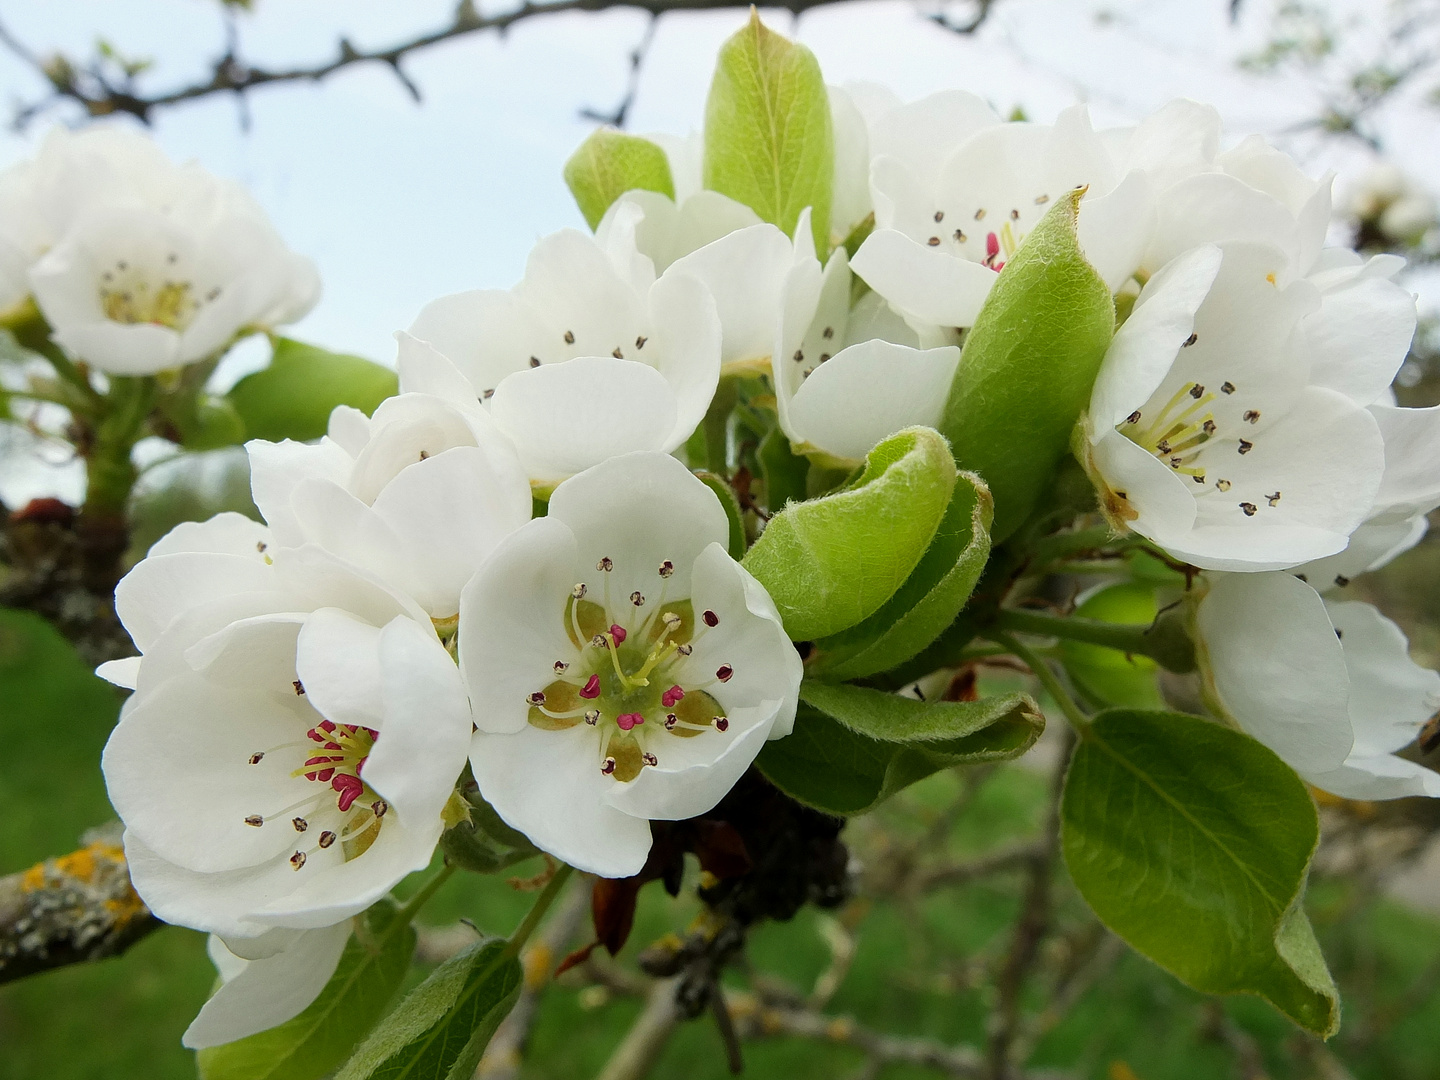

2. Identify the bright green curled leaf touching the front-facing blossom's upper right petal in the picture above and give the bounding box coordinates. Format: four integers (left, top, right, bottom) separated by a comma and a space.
744, 428, 955, 641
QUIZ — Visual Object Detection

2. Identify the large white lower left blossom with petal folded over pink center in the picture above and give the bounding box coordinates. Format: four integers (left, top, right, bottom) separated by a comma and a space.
101, 514, 472, 952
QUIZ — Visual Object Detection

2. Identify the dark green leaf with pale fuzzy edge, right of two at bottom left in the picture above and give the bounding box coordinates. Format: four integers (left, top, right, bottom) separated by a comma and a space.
336, 939, 524, 1080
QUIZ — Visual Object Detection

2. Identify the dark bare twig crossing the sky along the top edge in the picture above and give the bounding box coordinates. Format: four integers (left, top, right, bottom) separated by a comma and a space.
0, 0, 995, 128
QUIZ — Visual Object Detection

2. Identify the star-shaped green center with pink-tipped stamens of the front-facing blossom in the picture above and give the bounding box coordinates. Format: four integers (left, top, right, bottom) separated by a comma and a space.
527, 557, 734, 782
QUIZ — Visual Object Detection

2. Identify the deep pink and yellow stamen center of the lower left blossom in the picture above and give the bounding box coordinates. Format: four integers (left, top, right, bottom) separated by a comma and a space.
245, 694, 390, 870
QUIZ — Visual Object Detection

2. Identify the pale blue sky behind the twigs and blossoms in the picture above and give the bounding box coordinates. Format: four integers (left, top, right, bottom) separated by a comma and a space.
0, 0, 1436, 361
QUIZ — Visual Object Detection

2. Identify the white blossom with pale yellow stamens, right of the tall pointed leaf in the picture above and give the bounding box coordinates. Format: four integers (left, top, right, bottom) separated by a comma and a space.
1080, 242, 1384, 570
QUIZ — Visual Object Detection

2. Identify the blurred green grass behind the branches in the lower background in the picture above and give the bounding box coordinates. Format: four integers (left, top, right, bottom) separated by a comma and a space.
0, 596, 1440, 1080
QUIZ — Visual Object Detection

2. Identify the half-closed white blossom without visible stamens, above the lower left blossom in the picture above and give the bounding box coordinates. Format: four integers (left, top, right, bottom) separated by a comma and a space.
246, 388, 533, 619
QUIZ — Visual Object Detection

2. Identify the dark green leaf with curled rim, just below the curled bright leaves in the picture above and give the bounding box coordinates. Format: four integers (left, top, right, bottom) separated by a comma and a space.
756, 680, 1045, 815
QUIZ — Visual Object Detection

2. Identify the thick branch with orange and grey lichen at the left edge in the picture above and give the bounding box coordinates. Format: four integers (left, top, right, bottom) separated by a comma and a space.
0, 829, 160, 982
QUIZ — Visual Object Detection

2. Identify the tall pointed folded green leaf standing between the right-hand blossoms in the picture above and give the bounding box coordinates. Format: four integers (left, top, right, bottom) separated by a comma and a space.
940, 190, 1115, 543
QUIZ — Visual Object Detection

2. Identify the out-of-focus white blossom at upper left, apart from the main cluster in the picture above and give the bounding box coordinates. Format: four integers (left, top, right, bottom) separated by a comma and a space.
9, 128, 320, 374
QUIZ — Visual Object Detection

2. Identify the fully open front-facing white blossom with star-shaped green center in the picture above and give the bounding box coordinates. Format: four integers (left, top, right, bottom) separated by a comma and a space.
459, 452, 801, 877
